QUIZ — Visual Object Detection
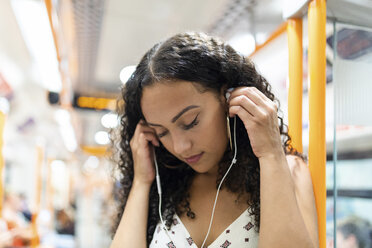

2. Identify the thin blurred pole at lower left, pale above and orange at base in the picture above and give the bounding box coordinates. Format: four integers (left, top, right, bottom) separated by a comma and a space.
31, 146, 44, 248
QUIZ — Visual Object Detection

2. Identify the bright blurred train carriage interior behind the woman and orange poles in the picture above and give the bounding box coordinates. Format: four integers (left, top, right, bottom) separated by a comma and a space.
0, 0, 372, 248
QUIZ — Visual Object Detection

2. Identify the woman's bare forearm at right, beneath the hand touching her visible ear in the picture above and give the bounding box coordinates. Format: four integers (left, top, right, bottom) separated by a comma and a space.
259, 153, 313, 248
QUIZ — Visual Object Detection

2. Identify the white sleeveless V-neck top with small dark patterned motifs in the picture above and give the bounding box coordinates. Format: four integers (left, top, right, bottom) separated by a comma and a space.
150, 210, 258, 248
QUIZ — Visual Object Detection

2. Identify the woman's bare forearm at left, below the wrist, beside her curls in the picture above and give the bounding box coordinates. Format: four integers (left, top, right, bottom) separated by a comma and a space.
110, 182, 150, 248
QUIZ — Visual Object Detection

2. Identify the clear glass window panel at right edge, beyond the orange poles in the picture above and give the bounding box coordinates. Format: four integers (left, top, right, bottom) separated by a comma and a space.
326, 23, 372, 248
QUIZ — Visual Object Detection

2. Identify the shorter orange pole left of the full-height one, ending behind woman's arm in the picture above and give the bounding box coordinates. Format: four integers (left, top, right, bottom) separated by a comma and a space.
287, 18, 303, 152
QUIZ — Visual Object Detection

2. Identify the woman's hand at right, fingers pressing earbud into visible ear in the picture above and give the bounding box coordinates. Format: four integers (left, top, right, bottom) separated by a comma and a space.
228, 87, 284, 158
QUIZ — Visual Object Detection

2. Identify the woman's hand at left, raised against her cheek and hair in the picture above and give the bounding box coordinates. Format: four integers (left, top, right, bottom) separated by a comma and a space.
130, 120, 159, 185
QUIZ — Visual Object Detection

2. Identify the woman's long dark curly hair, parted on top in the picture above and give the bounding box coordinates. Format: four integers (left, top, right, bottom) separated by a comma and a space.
114, 33, 298, 243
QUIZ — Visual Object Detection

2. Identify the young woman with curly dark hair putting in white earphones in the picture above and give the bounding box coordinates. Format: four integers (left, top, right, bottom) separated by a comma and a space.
111, 33, 318, 248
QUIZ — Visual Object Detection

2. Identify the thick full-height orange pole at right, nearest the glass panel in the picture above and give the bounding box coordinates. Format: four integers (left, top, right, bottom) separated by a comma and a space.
308, 0, 327, 248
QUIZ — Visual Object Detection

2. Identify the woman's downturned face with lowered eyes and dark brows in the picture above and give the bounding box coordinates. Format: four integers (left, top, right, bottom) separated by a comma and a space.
141, 81, 228, 173
